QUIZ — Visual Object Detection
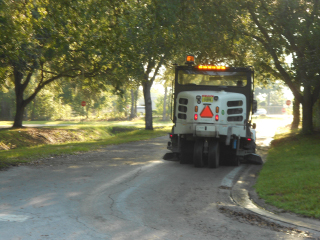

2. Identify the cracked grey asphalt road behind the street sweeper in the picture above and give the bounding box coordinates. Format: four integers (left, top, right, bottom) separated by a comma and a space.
0, 117, 318, 240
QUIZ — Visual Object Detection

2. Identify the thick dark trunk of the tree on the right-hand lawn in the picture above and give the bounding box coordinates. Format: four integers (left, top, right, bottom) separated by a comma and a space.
302, 85, 313, 134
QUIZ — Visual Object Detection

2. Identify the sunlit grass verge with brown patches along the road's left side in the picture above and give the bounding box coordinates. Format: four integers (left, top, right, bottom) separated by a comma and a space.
0, 120, 171, 169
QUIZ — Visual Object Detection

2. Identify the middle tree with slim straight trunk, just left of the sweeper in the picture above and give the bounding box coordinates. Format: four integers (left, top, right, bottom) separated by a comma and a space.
121, 0, 212, 130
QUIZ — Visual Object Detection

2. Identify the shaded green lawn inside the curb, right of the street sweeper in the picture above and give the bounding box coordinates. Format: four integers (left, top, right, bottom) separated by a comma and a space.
255, 132, 320, 219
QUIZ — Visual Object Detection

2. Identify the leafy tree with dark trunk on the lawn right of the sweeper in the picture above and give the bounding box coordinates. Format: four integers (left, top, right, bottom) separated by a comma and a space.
235, 0, 320, 133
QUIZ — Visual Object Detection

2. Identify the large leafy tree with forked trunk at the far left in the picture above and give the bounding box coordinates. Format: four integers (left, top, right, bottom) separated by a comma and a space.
0, 0, 122, 127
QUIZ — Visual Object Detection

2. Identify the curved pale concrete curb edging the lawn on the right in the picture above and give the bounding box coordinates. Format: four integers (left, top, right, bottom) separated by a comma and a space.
231, 165, 320, 233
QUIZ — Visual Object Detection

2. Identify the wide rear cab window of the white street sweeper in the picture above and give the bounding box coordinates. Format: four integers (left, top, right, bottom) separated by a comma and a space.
178, 70, 247, 87
